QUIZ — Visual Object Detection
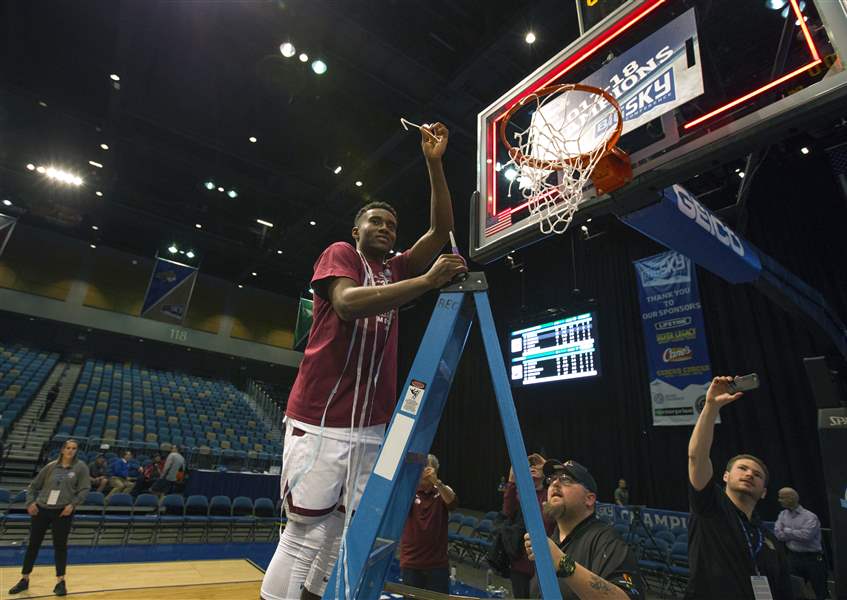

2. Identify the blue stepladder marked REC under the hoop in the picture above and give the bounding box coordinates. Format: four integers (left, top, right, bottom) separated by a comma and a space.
323, 272, 561, 599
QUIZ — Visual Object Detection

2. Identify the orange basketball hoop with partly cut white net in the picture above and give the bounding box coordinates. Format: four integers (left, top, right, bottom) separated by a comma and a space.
500, 84, 632, 234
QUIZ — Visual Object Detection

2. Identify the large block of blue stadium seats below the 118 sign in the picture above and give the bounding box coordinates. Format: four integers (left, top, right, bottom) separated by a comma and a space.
54, 360, 282, 468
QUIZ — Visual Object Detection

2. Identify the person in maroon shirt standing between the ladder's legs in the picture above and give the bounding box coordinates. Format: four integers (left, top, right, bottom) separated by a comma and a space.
400, 454, 459, 594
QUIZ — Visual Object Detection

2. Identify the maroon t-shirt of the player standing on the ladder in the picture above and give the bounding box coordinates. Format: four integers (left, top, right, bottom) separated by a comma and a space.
285, 242, 408, 427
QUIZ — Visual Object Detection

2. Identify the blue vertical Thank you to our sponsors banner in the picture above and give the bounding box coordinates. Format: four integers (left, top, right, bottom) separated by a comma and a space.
633, 250, 712, 425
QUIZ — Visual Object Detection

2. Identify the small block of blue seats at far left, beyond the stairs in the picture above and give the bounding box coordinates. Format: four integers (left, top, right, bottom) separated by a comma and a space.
0, 342, 59, 438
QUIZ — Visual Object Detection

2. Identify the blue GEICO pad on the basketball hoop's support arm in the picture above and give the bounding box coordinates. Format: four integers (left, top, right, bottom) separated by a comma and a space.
621, 185, 762, 283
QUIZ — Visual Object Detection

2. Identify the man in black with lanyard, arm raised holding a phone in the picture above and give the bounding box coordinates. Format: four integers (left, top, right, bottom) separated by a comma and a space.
685, 377, 793, 600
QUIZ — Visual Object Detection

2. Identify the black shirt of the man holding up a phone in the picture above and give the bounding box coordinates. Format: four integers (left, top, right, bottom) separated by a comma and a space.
685, 482, 793, 600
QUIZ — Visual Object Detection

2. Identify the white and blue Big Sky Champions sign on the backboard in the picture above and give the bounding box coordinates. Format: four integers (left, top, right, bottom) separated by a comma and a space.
530, 8, 703, 160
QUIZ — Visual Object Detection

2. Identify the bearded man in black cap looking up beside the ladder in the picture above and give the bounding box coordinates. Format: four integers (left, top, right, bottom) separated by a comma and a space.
524, 460, 645, 600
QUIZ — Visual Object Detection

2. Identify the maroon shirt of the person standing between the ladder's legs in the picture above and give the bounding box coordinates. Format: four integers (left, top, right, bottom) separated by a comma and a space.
400, 487, 458, 569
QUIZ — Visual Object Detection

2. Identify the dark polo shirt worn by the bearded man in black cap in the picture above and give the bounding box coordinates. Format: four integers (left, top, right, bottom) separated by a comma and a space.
530, 515, 646, 600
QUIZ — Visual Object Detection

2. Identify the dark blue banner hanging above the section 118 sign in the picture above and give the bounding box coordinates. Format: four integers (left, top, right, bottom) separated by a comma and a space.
141, 257, 202, 325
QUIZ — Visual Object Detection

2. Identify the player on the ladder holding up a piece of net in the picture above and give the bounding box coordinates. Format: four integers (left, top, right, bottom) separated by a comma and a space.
261, 123, 467, 600
